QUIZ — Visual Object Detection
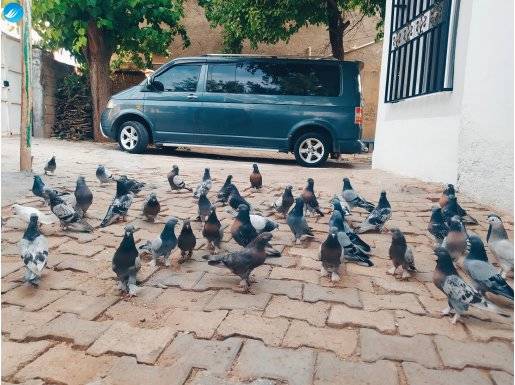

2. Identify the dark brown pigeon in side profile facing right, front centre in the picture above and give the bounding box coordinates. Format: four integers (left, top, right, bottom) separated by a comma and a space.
208, 233, 278, 293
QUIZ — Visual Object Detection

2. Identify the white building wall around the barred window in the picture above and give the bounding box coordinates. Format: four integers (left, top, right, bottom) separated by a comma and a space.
372, 0, 513, 210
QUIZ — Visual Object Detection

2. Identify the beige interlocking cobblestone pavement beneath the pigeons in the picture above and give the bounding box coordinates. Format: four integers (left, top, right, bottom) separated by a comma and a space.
2, 138, 513, 385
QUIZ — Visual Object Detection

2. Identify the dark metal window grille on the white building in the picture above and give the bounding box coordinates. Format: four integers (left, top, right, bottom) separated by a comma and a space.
384, 0, 458, 103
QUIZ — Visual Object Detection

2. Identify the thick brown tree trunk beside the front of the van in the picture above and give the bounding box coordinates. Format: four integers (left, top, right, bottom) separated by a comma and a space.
86, 20, 112, 142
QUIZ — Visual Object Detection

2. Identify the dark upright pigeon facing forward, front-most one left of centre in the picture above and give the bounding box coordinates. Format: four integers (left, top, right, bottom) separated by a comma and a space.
113, 225, 141, 297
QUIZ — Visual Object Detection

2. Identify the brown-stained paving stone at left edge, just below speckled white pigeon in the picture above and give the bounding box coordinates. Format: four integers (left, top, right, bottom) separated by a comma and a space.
2, 285, 67, 311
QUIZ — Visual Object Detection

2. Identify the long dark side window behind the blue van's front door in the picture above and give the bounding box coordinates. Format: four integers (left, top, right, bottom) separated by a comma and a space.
206, 61, 340, 96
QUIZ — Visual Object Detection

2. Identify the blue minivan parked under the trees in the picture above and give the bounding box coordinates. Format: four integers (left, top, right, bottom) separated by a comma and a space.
100, 55, 366, 167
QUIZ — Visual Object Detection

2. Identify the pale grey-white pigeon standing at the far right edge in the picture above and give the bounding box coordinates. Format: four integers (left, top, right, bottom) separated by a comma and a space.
486, 214, 513, 278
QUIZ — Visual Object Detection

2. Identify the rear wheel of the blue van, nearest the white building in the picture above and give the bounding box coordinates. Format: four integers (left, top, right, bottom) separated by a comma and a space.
293, 132, 330, 167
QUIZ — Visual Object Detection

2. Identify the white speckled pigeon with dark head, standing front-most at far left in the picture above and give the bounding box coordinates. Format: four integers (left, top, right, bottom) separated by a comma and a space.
20, 214, 48, 286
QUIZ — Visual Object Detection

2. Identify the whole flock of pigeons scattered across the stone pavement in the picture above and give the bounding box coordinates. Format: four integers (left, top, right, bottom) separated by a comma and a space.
13, 157, 513, 323
